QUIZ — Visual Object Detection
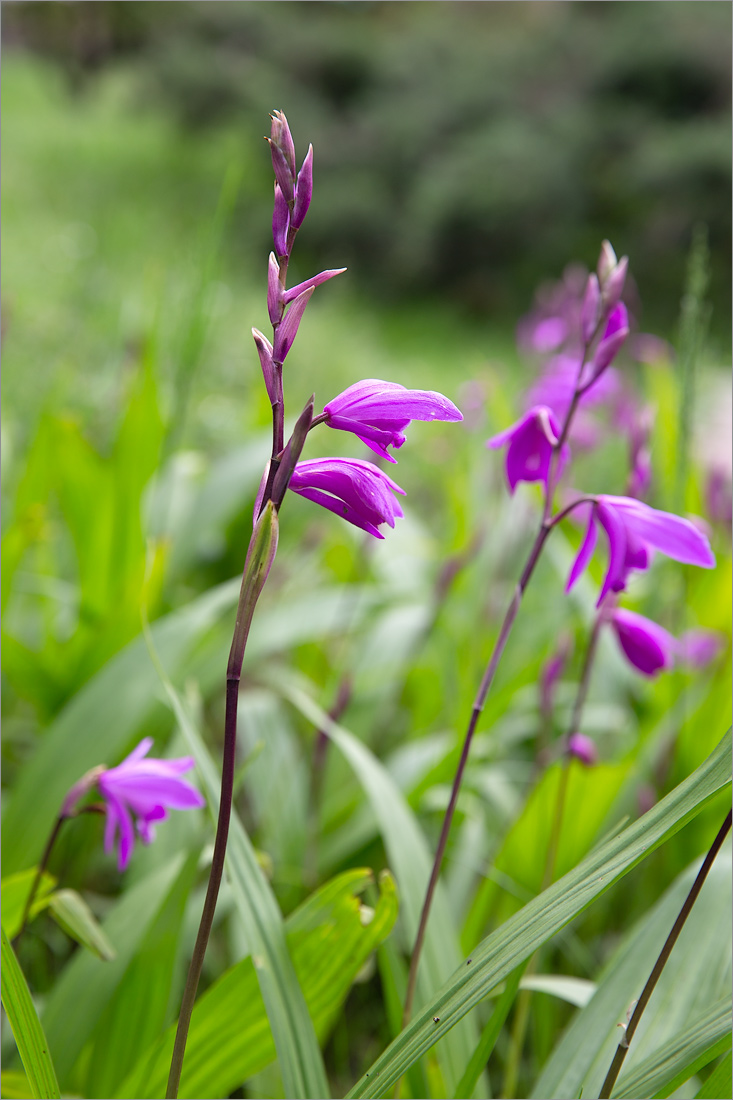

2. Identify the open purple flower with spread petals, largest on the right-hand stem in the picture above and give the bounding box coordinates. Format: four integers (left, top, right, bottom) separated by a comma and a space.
565, 496, 715, 607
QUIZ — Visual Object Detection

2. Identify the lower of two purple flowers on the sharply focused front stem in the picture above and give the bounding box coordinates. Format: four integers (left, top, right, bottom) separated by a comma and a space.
289, 459, 405, 539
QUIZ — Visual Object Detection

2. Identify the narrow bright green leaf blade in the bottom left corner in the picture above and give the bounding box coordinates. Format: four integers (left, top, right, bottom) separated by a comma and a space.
2, 928, 61, 1097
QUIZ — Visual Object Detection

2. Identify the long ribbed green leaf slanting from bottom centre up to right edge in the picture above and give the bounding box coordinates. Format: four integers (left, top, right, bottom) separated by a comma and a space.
349, 732, 731, 1097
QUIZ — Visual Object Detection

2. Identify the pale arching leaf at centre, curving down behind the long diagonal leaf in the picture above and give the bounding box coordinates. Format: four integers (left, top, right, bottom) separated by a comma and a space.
271, 677, 479, 1093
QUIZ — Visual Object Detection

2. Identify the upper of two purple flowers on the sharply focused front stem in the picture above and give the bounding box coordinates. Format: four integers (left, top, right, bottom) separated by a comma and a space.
324, 378, 463, 462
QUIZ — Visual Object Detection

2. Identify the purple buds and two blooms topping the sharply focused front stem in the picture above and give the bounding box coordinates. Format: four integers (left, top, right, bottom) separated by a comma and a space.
252, 111, 462, 538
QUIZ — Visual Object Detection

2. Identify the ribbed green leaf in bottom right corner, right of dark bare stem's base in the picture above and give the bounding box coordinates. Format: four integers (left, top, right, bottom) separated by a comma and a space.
611, 996, 733, 1100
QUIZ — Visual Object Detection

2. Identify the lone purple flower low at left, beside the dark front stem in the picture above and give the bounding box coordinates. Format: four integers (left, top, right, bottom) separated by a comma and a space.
97, 737, 206, 871
